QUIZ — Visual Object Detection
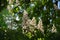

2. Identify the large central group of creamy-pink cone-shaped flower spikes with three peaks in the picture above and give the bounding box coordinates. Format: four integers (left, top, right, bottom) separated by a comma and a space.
22, 10, 44, 33
